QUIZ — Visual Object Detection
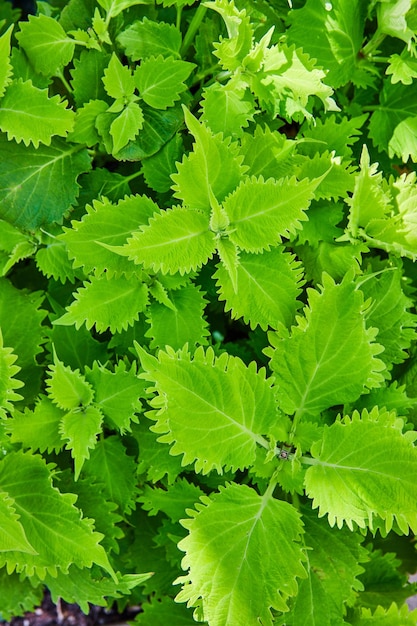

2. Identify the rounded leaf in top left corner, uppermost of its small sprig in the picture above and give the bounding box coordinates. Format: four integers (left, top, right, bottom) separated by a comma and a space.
16, 13, 74, 76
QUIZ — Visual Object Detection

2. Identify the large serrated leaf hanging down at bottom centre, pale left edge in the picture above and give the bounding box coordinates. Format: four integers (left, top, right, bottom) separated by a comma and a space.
176, 483, 305, 626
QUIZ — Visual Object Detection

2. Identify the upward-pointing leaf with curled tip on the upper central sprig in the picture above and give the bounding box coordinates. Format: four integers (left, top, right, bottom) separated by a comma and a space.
172, 108, 247, 212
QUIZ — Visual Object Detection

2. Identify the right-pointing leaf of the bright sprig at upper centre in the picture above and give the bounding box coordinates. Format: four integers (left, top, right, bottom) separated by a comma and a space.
223, 176, 317, 253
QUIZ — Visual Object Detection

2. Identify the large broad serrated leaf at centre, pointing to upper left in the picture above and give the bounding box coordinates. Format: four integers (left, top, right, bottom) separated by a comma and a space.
137, 346, 277, 474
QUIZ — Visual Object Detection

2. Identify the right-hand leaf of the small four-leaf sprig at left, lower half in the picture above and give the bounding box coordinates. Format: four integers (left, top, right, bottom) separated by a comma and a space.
86, 361, 146, 434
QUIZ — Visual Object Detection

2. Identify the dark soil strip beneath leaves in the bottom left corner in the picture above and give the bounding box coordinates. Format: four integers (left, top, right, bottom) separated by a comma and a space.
0, 592, 140, 626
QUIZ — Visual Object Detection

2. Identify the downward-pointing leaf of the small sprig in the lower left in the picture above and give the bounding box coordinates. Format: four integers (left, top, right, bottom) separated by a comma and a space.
59, 406, 103, 480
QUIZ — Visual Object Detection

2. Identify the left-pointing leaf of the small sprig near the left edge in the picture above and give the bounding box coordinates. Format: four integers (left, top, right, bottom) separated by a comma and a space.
6, 395, 65, 453
